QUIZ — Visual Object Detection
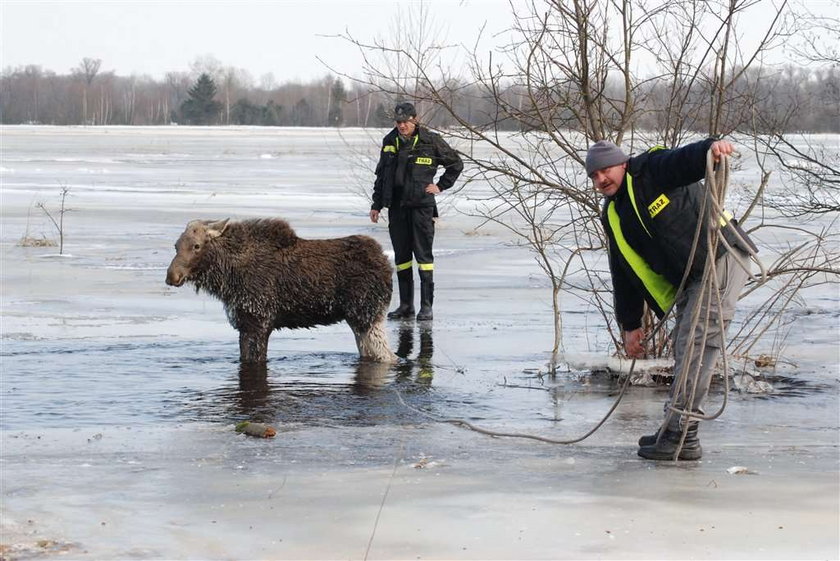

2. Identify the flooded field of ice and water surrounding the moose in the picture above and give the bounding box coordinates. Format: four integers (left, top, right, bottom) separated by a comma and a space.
0, 127, 840, 559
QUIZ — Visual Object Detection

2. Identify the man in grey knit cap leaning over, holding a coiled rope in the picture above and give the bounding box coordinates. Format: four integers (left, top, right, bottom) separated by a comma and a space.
585, 139, 756, 460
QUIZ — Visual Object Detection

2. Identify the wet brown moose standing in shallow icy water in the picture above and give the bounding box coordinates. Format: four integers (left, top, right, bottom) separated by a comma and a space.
166, 219, 396, 363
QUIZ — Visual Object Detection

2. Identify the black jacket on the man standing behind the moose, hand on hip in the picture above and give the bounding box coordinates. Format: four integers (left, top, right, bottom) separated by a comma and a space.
370, 126, 464, 210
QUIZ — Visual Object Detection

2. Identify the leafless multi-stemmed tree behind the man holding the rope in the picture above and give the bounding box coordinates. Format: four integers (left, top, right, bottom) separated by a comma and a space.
334, 0, 831, 366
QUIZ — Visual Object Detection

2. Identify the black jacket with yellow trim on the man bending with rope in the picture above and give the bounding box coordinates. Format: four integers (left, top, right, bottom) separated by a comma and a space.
601, 138, 754, 331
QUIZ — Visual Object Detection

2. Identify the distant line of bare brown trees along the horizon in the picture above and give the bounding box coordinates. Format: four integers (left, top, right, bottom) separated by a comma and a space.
0, 58, 840, 133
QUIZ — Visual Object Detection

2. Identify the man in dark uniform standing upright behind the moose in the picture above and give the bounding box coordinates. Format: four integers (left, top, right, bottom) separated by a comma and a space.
370, 102, 464, 320
